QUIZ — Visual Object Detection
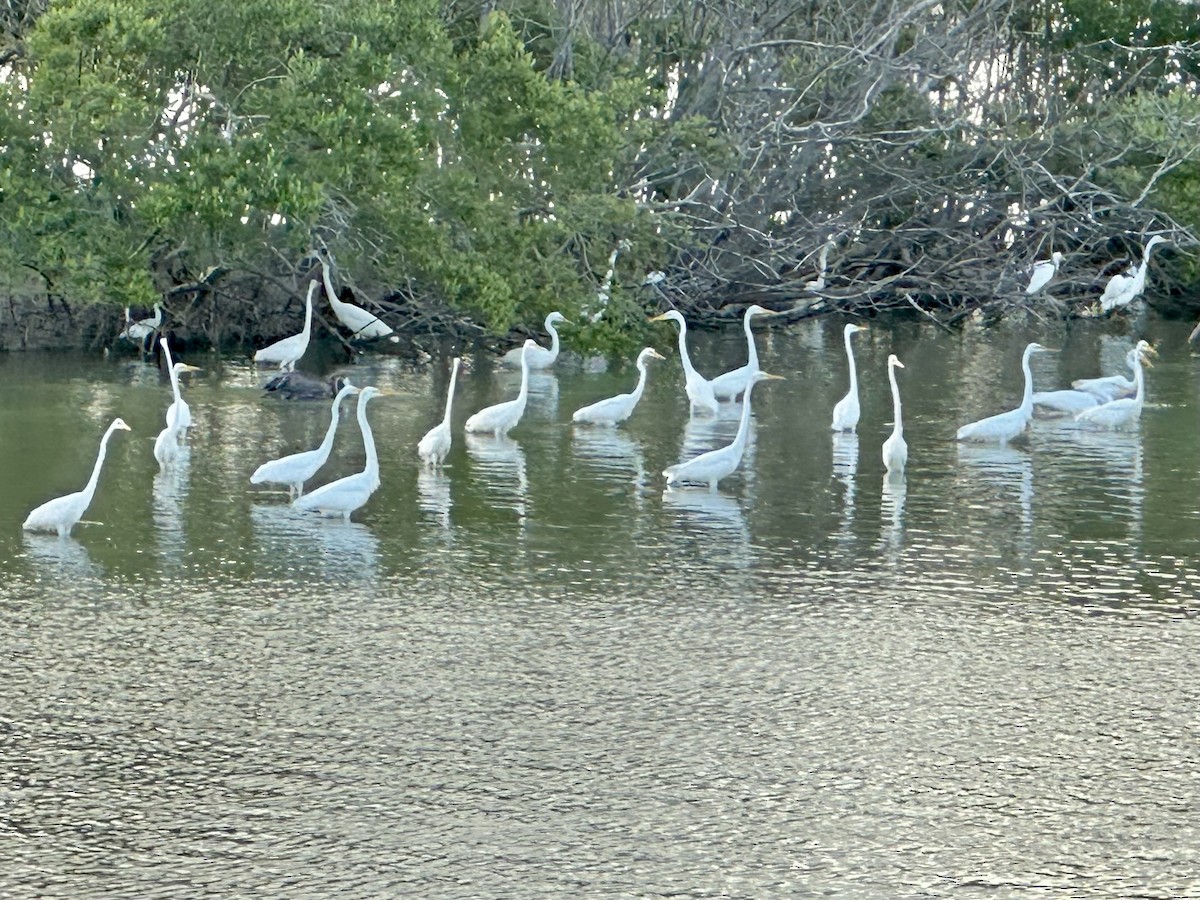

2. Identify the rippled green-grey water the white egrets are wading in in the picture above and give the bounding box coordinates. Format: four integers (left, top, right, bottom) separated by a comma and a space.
0, 320, 1200, 898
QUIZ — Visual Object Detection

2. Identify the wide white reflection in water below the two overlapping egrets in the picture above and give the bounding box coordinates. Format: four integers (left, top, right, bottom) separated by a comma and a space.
250, 504, 379, 583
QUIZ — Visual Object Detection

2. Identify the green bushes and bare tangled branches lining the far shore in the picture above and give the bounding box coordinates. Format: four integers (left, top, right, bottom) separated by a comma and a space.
0, 0, 1200, 354
